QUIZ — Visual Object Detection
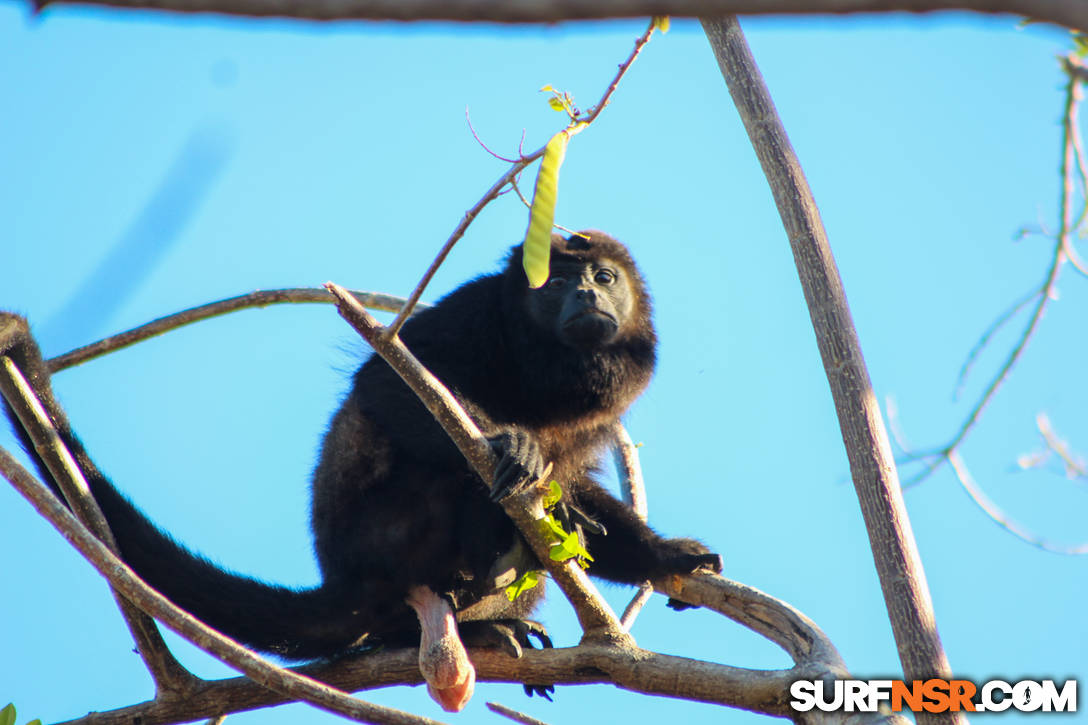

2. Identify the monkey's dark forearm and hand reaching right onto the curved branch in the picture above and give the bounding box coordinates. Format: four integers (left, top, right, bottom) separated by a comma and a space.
571, 480, 721, 583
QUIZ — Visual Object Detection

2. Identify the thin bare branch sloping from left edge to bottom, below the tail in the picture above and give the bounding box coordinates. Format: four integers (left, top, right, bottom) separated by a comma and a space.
0, 447, 446, 725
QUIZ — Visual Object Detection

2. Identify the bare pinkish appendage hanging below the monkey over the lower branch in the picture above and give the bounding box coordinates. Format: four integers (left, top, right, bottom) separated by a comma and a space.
405, 587, 475, 712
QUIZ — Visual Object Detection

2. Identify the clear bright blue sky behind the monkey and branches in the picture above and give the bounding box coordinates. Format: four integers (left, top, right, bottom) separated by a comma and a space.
0, 2, 1088, 725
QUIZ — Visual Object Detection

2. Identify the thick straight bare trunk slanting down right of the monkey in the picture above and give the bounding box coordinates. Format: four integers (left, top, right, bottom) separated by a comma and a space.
703, 17, 962, 723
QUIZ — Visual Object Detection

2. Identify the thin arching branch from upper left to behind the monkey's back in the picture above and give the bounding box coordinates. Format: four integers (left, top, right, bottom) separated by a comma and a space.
46, 287, 415, 372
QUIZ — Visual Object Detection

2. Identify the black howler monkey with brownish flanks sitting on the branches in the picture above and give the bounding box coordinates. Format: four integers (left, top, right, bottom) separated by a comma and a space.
8, 232, 720, 705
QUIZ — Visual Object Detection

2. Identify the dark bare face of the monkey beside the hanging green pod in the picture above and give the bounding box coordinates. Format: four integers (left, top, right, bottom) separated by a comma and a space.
528, 258, 634, 348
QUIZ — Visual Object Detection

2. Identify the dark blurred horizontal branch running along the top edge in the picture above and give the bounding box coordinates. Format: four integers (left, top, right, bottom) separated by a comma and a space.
25, 0, 1088, 28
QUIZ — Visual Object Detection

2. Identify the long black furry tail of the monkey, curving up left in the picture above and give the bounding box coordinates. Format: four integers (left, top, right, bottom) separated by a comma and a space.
4, 402, 375, 660
